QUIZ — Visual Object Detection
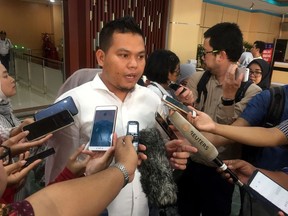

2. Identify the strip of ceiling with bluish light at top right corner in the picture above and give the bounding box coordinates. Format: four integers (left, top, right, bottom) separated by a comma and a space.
203, 0, 288, 16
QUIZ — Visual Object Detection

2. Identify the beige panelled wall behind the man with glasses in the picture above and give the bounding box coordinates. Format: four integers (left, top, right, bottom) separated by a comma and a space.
168, 0, 282, 62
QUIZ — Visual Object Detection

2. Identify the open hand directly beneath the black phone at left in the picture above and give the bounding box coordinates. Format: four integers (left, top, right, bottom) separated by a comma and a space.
2, 131, 52, 156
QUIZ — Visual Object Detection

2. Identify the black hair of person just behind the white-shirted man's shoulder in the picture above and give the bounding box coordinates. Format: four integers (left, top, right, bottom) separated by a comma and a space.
144, 50, 180, 84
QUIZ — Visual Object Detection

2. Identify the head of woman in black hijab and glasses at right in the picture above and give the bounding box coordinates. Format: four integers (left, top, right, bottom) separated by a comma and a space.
247, 59, 271, 90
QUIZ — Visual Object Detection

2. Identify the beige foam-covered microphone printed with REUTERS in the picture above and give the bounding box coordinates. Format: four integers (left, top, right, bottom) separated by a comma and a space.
169, 111, 244, 187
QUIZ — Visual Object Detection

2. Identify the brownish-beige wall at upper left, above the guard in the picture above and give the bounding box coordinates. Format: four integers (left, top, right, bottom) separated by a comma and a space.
0, 0, 62, 50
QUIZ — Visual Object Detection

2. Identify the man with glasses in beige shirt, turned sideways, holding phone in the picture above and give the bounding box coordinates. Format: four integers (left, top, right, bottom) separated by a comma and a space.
178, 23, 261, 216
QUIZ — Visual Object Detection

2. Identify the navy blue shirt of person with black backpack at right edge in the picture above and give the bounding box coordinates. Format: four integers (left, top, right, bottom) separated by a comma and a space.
240, 85, 288, 170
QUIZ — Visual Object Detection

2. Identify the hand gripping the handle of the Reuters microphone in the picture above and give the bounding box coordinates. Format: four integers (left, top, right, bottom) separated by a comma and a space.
217, 159, 256, 184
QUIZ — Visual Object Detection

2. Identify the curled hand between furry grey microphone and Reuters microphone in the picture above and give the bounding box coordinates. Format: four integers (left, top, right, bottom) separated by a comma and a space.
165, 139, 197, 170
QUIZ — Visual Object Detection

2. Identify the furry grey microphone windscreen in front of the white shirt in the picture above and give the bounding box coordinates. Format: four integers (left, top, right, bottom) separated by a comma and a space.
138, 128, 179, 216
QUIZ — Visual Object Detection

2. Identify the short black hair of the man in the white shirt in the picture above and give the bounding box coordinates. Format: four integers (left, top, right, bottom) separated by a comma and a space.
99, 16, 144, 52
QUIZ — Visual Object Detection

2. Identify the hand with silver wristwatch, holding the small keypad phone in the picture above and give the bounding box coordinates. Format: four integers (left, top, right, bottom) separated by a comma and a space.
115, 135, 138, 182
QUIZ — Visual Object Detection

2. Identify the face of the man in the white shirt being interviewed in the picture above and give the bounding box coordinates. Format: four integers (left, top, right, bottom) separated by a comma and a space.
96, 33, 145, 93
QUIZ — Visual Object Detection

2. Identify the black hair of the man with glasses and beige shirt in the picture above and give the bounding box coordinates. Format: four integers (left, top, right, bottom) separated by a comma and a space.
204, 22, 243, 62
